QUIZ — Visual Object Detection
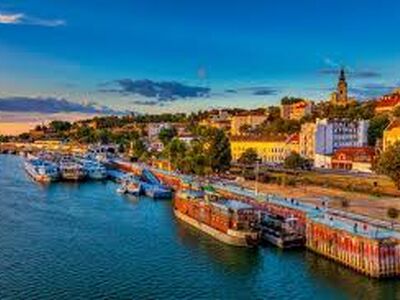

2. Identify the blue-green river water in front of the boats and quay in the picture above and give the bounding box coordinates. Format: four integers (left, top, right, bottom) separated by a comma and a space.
0, 155, 400, 299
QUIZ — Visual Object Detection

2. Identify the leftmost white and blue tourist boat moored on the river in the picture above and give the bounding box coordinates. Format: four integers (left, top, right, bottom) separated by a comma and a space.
24, 159, 60, 182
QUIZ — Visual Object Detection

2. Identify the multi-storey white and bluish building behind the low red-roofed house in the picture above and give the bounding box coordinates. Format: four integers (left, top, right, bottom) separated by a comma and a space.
314, 119, 369, 168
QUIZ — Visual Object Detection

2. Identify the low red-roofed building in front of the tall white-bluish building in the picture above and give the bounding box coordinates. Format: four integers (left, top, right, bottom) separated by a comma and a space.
331, 147, 375, 173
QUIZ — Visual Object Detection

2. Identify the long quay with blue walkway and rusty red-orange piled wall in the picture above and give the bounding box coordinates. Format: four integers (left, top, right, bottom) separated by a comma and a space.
117, 163, 400, 278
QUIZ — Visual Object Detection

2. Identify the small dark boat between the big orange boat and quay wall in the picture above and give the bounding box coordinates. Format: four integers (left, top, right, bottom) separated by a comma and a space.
260, 214, 306, 249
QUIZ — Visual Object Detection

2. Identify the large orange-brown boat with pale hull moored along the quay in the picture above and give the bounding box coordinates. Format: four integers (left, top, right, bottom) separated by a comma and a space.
174, 190, 259, 247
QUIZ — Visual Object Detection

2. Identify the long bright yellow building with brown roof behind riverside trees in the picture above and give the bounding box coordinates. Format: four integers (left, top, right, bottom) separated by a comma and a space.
231, 134, 299, 163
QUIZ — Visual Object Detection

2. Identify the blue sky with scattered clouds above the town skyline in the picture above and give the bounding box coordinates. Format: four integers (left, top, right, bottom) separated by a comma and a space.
0, 0, 400, 112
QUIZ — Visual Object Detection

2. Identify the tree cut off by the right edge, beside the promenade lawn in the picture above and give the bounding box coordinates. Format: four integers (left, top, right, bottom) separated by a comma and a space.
377, 142, 400, 190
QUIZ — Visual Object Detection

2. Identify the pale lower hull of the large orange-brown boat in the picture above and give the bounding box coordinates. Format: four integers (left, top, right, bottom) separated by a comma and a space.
174, 209, 258, 247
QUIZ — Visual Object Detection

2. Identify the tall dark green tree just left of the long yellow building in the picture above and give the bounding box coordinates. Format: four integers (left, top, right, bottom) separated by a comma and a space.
209, 129, 232, 173
